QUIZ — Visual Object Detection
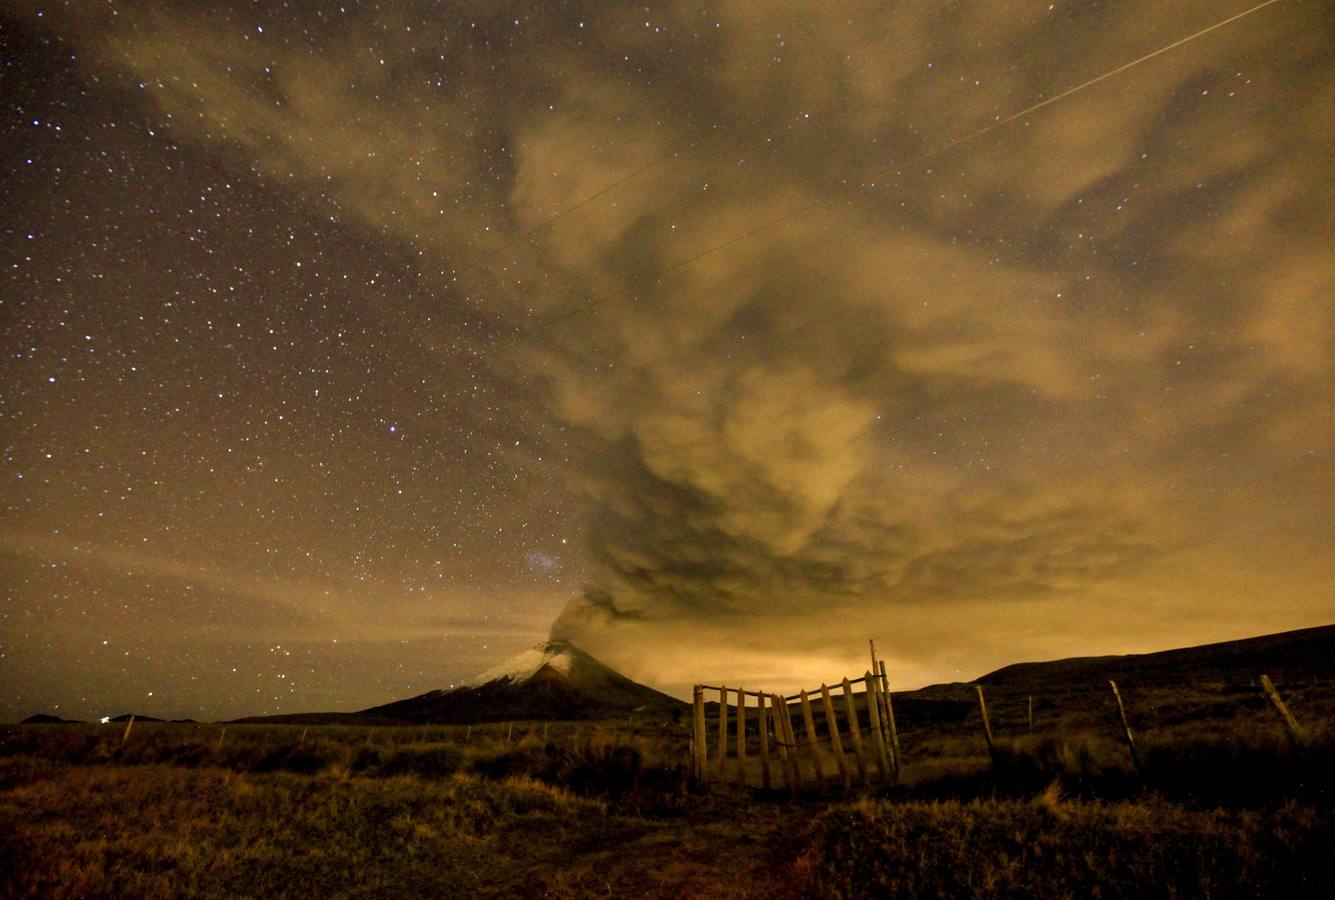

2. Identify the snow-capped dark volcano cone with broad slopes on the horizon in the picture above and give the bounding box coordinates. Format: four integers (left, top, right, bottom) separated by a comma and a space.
238, 641, 686, 725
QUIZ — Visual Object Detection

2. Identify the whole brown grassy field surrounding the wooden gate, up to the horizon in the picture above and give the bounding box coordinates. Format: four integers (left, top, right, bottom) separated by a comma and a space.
0, 705, 1335, 897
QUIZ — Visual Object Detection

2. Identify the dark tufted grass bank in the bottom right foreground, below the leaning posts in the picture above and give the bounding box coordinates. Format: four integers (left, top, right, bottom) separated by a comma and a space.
794, 788, 1335, 899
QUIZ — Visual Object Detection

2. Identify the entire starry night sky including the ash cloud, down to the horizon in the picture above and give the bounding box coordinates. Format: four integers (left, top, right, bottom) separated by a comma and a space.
0, 0, 1335, 720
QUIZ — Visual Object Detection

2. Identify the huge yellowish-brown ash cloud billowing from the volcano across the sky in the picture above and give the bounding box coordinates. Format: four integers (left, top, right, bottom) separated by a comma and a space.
5, 1, 1335, 715
